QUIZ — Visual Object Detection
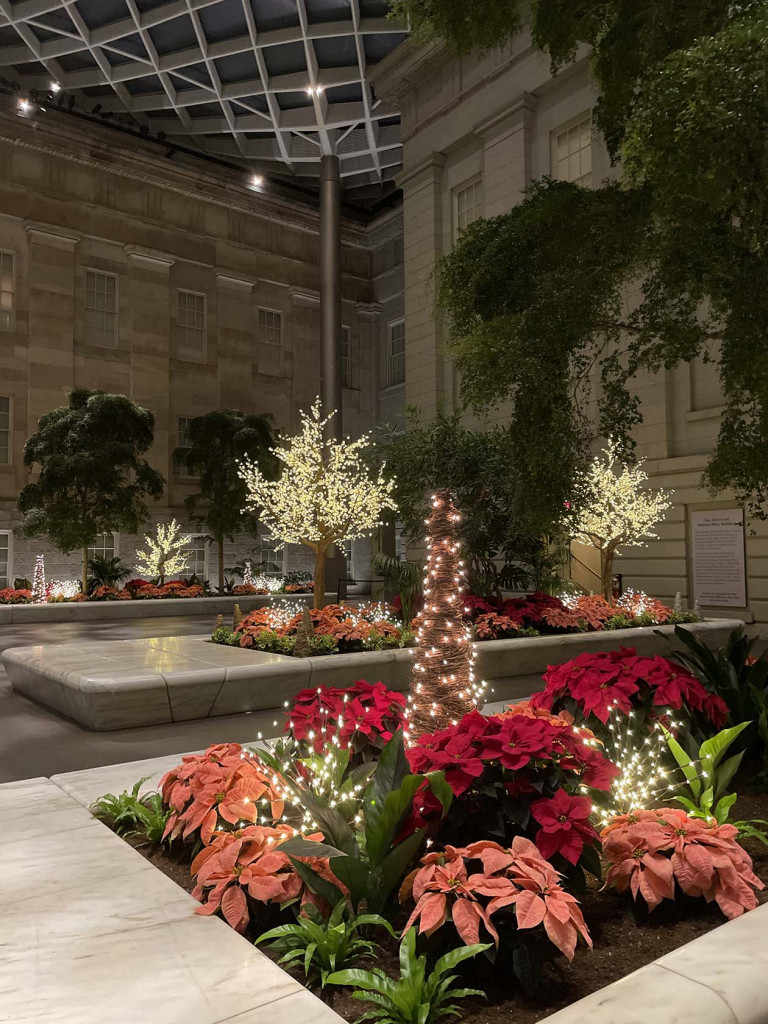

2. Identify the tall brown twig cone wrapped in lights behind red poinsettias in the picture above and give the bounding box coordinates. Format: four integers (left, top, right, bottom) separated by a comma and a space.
408, 490, 484, 742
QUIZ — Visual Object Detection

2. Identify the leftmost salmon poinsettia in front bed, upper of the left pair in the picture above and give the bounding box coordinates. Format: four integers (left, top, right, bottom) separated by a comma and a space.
160, 743, 287, 846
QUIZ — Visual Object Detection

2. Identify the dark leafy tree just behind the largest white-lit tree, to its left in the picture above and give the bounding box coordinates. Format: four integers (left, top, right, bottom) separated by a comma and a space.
173, 409, 279, 593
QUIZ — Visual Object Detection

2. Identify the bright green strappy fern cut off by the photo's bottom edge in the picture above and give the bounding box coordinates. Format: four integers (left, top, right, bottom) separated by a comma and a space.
326, 928, 490, 1024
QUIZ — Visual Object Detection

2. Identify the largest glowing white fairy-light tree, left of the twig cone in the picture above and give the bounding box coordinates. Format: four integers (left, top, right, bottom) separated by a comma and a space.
241, 398, 396, 608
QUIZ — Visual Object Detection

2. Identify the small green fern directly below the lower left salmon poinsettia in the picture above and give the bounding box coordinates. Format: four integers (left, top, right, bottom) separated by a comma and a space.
256, 900, 395, 988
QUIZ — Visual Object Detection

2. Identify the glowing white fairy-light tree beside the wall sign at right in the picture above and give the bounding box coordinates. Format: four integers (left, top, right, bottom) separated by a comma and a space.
563, 439, 674, 601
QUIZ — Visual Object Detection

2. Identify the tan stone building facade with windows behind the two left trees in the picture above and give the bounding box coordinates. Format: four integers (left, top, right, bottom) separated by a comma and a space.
0, 109, 402, 587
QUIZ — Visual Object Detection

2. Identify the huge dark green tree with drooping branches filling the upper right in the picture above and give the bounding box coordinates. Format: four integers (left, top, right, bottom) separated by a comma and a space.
398, 0, 768, 518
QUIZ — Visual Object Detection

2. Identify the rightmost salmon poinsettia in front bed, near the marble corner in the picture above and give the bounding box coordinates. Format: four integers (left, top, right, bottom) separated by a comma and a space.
601, 808, 764, 918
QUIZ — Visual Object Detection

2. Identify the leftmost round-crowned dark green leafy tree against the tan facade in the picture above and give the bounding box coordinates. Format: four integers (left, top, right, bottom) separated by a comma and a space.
18, 388, 165, 593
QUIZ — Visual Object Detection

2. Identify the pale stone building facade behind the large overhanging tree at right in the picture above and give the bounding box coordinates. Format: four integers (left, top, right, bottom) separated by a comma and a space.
371, 31, 768, 631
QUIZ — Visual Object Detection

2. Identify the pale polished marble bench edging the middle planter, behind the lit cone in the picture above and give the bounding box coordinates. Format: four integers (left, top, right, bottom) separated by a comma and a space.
3, 620, 740, 731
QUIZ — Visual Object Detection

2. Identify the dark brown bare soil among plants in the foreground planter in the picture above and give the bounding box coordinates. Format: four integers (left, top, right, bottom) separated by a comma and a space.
120, 779, 768, 1024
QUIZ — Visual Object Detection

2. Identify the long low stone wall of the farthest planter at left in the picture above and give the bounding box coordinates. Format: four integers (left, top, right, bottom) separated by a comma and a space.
0, 594, 321, 626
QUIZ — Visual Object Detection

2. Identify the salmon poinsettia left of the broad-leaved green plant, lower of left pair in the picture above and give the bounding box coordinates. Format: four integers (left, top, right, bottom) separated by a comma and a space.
191, 824, 345, 932
